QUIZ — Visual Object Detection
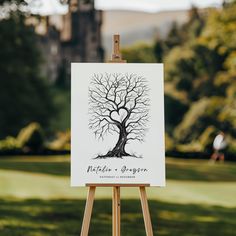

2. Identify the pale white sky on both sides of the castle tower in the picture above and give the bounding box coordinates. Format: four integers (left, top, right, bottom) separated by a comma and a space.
24, 0, 223, 15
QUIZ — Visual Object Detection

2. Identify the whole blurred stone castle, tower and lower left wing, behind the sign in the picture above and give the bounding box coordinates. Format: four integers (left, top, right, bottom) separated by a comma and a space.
39, 0, 104, 81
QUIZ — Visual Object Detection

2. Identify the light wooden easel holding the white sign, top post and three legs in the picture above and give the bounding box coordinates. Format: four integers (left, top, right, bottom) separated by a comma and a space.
80, 35, 153, 236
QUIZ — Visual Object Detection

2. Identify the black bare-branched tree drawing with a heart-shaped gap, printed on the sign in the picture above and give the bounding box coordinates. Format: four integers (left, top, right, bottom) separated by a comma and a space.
89, 73, 149, 158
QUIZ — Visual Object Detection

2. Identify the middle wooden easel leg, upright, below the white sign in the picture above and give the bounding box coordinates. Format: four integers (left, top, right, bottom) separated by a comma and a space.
112, 186, 120, 236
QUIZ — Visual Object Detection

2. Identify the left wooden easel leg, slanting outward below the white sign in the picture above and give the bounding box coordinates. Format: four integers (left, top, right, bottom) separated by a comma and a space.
80, 186, 96, 236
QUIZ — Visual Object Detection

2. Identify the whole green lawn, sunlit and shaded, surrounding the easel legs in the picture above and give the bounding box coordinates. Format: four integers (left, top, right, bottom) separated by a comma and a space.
0, 156, 236, 236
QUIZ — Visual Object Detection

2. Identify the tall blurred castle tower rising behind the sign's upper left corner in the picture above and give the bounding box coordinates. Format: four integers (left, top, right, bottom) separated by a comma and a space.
61, 0, 103, 62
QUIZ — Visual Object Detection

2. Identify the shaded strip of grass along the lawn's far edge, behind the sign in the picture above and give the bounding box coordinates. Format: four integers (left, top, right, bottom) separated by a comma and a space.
0, 156, 236, 182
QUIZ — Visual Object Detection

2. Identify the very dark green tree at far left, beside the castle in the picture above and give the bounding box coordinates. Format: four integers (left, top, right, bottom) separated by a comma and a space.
0, 10, 55, 138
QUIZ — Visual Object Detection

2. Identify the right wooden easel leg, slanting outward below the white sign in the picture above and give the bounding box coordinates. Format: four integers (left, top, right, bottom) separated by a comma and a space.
139, 186, 153, 236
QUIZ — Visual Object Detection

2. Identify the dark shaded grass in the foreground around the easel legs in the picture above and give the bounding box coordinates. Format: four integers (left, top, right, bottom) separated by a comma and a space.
0, 200, 236, 236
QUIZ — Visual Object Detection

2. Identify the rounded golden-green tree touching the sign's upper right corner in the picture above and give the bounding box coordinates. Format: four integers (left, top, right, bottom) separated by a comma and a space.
166, 43, 225, 101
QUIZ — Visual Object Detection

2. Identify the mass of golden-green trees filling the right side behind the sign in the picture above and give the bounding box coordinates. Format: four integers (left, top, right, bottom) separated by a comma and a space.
123, 3, 236, 156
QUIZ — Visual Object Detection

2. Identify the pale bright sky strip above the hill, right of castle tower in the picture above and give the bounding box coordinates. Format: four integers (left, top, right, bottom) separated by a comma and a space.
95, 0, 222, 12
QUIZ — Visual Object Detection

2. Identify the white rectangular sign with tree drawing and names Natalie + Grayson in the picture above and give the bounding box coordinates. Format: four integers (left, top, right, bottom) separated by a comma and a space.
71, 63, 165, 186
